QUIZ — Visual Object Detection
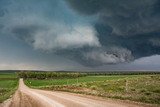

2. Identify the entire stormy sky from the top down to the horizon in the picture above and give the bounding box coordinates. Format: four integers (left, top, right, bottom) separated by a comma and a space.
0, 0, 160, 70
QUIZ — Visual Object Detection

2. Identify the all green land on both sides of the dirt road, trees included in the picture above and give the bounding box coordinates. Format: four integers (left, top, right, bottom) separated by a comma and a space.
0, 72, 160, 104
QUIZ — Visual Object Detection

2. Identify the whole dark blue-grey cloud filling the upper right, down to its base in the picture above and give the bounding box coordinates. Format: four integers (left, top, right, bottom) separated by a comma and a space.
67, 0, 160, 65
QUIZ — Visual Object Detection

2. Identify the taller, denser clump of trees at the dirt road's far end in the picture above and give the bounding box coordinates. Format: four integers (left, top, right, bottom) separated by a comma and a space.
17, 71, 87, 79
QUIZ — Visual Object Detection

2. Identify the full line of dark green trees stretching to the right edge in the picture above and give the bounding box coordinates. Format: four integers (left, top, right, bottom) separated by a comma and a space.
17, 71, 160, 79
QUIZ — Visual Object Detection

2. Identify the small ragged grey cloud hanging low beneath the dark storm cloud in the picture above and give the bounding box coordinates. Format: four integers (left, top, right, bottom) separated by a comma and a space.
83, 47, 133, 64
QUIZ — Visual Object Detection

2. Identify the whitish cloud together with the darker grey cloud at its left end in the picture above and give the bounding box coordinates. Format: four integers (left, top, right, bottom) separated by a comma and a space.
10, 18, 101, 51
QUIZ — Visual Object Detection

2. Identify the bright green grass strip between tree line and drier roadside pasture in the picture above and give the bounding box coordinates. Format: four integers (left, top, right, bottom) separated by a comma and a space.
25, 75, 136, 88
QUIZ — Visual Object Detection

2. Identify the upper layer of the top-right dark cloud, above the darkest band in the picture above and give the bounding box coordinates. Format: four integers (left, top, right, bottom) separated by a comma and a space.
67, 0, 160, 36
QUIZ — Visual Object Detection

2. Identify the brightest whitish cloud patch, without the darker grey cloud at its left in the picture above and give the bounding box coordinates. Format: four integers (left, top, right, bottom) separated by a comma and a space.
32, 25, 100, 50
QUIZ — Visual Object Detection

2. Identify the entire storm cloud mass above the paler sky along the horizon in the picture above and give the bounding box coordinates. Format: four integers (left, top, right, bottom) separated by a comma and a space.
0, 0, 160, 66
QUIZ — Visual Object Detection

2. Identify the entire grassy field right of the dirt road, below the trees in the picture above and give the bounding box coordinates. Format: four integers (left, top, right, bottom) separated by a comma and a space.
25, 74, 160, 104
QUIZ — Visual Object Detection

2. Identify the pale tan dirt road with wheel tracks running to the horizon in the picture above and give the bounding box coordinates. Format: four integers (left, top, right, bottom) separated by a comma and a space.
1, 79, 156, 107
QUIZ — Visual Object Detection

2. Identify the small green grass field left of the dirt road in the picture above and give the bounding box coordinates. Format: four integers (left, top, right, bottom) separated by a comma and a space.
0, 73, 18, 103
